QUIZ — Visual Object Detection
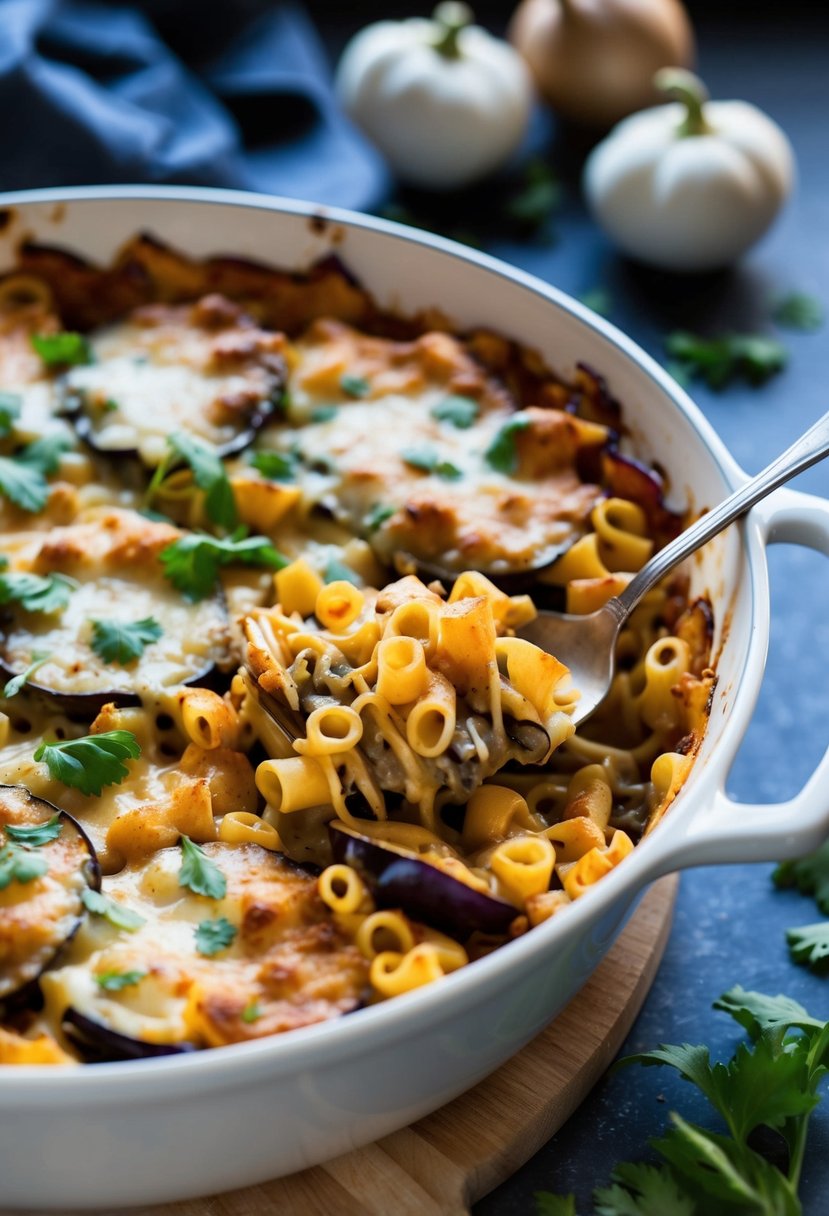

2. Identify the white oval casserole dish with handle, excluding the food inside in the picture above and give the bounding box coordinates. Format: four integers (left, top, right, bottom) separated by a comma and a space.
0, 187, 829, 1211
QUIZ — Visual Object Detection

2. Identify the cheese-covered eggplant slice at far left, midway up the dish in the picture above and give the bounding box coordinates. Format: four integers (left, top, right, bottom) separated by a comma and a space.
0, 511, 230, 716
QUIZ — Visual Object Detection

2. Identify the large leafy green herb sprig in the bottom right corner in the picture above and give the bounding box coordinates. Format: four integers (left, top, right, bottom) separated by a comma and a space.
536, 986, 829, 1216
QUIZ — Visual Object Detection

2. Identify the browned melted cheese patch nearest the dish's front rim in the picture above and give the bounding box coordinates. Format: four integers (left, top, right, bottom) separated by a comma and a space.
41, 843, 368, 1046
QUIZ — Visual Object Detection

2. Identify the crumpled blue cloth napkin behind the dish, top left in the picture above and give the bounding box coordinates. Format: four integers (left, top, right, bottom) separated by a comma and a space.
0, 0, 388, 209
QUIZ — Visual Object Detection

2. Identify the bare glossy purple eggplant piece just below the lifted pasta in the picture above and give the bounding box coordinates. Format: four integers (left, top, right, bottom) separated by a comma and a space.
328, 823, 519, 939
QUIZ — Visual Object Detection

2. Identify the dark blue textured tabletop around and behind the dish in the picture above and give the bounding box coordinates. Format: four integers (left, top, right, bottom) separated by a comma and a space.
316, 2, 829, 1216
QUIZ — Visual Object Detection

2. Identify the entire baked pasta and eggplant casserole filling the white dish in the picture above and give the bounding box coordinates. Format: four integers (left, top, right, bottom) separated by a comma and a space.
0, 236, 715, 1065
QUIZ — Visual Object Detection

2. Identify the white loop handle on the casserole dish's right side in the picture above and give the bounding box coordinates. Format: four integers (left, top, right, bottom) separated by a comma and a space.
666, 490, 829, 869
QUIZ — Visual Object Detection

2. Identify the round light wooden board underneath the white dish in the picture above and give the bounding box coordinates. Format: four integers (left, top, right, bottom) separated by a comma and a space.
6, 876, 678, 1216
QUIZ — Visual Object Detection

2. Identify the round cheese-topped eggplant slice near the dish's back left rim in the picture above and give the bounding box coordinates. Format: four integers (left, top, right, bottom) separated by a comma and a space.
62, 295, 287, 467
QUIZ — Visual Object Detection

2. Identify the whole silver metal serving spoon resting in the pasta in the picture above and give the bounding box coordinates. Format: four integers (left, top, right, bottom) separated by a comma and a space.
520, 413, 829, 724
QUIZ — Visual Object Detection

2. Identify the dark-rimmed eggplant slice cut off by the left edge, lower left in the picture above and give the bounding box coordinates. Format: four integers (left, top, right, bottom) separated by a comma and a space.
0, 786, 101, 1001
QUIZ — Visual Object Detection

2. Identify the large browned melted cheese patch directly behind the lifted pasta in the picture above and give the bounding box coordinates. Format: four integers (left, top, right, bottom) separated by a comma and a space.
255, 321, 607, 572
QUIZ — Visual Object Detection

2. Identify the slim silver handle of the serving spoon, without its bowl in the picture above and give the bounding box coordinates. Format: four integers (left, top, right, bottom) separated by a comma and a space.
615, 413, 829, 620
